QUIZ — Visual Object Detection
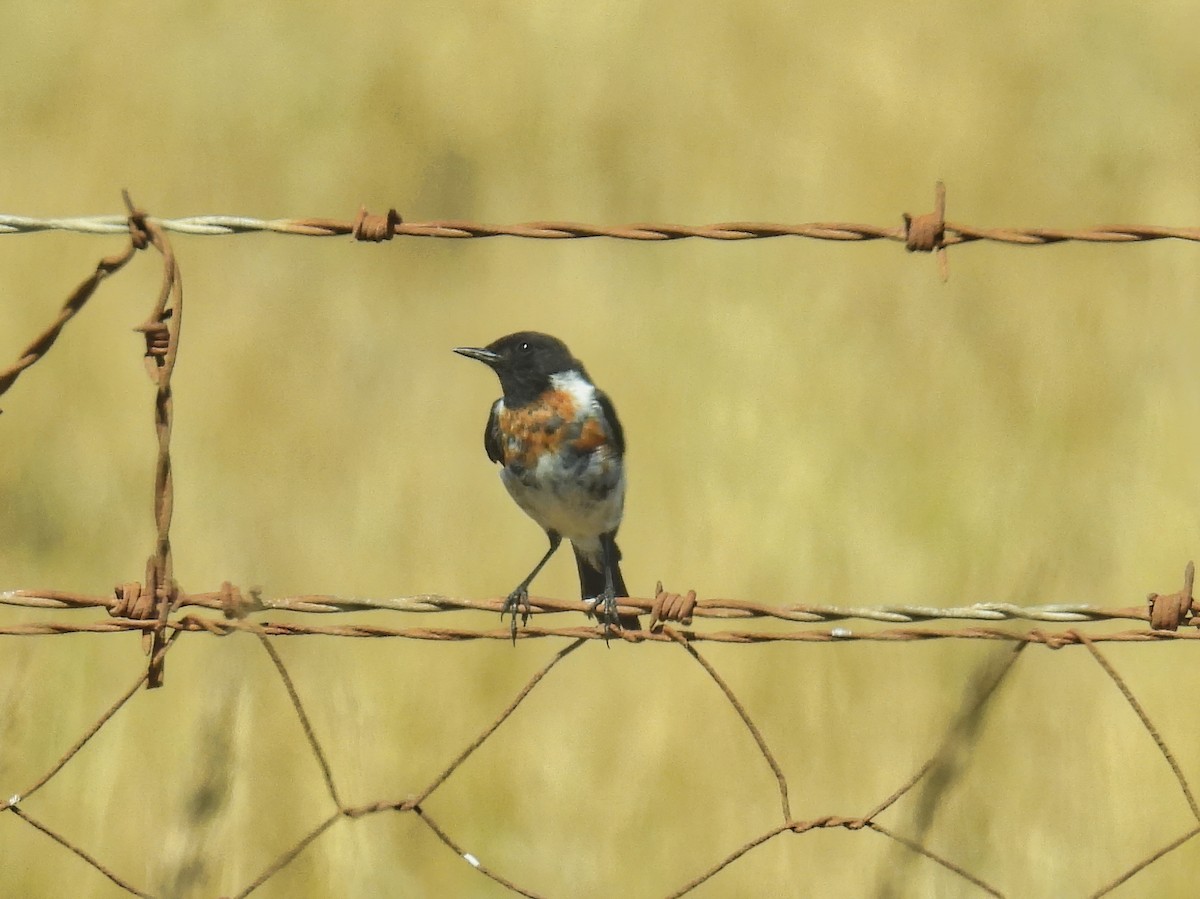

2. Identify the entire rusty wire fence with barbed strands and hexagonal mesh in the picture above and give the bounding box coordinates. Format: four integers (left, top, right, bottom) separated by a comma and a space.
0, 185, 1200, 897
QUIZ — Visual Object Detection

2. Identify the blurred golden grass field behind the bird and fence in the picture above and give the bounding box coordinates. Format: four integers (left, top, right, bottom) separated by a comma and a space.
0, 0, 1200, 897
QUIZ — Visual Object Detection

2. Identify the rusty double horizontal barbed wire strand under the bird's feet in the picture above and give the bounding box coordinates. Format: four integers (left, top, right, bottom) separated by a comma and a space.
0, 562, 1200, 645
